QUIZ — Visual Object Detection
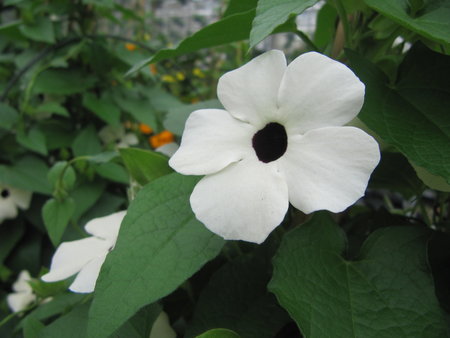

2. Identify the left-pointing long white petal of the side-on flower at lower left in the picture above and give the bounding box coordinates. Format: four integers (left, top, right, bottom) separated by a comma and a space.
41, 237, 111, 282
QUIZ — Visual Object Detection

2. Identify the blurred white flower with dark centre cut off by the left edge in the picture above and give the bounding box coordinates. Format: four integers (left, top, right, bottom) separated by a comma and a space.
0, 184, 31, 223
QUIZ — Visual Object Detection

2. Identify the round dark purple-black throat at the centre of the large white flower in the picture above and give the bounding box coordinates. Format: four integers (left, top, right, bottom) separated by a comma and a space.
252, 122, 287, 163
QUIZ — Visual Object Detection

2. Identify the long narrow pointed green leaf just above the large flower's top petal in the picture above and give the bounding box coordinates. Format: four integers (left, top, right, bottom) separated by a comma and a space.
125, 9, 255, 76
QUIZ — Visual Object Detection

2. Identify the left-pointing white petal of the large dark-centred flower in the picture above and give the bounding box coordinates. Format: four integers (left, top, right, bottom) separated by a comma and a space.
169, 109, 256, 175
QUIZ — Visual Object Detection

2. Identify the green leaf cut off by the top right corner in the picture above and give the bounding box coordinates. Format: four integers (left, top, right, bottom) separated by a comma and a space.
364, 0, 450, 44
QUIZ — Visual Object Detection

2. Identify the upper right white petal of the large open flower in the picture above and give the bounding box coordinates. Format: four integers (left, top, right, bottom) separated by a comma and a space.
278, 52, 364, 134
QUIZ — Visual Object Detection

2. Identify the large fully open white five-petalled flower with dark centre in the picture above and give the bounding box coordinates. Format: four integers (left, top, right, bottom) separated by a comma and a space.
169, 50, 380, 243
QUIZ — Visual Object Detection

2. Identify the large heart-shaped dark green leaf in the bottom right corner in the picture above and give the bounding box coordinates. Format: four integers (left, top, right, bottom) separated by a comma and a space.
269, 213, 450, 338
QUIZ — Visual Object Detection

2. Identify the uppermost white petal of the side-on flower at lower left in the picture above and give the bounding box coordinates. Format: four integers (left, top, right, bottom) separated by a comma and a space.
84, 210, 127, 246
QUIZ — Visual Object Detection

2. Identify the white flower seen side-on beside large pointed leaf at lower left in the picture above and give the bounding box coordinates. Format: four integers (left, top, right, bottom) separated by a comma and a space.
41, 211, 126, 293
